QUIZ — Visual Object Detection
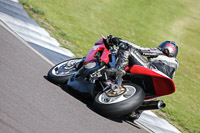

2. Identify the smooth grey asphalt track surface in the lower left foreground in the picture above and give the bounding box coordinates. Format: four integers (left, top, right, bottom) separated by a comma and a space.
0, 25, 147, 133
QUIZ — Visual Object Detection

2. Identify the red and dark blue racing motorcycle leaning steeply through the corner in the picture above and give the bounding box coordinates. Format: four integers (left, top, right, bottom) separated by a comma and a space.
48, 36, 175, 120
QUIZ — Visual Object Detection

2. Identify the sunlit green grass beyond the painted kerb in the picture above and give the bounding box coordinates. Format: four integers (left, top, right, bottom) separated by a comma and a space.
20, 0, 200, 132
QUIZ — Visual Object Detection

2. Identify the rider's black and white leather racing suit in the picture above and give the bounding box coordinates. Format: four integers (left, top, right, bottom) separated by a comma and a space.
116, 40, 178, 79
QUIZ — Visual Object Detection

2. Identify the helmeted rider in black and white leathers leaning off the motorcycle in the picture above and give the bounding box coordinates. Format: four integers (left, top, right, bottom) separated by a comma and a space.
106, 35, 178, 79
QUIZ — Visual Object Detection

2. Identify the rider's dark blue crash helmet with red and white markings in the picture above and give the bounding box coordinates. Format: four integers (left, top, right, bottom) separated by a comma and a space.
158, 41, 178, 57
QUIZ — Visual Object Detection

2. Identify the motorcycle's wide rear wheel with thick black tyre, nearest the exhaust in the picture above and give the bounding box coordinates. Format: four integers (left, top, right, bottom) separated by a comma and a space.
93, 83, 145, 117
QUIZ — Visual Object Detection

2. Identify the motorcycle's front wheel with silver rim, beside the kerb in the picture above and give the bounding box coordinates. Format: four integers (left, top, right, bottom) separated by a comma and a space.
48, 58, 82, 84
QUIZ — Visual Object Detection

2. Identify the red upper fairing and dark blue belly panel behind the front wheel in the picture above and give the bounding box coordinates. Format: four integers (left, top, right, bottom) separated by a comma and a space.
67, 38, 110, 98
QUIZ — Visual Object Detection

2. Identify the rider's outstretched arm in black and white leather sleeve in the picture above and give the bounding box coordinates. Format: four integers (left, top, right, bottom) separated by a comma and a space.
120, 40, 163, 58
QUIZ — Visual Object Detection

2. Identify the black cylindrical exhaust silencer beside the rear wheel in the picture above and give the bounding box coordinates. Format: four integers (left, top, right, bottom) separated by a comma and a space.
137, 100, 166, 110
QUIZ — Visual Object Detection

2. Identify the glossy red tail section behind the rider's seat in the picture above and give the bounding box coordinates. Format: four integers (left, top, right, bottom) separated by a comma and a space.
130, 65, 176, 97
